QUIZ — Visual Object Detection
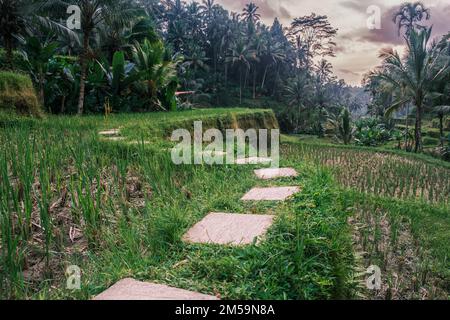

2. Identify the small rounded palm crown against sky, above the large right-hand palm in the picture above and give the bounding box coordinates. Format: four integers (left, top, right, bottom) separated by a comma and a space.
392, 2, 430, 36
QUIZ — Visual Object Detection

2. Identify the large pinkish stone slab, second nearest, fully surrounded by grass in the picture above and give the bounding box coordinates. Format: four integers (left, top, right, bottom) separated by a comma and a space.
183, 213, 274, 246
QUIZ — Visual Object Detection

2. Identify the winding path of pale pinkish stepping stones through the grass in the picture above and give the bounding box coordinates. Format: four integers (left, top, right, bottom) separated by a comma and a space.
94, 146, 300, 300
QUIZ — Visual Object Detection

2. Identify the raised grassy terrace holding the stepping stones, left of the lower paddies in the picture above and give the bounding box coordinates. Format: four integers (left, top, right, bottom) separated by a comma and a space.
0, 109, 355, 299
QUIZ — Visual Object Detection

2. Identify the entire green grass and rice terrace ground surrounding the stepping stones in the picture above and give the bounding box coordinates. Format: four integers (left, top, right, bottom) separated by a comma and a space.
0, 109, 450, 299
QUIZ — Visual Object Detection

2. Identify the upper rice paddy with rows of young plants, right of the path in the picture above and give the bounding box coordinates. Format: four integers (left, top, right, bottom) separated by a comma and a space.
284, 143, 450, 205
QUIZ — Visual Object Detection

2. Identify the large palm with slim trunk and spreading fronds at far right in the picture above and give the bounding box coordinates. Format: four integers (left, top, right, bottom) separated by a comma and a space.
373, 28, 449, 152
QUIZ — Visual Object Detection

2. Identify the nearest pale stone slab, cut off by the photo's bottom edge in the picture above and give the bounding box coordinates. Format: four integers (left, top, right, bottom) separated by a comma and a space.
94, 278, 219, 300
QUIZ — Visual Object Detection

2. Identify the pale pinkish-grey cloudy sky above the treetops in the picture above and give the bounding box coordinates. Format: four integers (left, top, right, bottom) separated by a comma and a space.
211, 0, 450, 85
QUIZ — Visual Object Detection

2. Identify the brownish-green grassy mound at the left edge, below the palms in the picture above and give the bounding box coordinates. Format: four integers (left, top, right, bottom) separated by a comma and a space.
0, 71, 41, 116
